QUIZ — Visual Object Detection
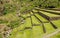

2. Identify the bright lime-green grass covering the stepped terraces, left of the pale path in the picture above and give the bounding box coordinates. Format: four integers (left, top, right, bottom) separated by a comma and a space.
9, 8, 60, 38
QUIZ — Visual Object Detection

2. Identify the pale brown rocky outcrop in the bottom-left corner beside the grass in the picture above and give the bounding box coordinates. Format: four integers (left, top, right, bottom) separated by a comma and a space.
0, 24, 12, 38
